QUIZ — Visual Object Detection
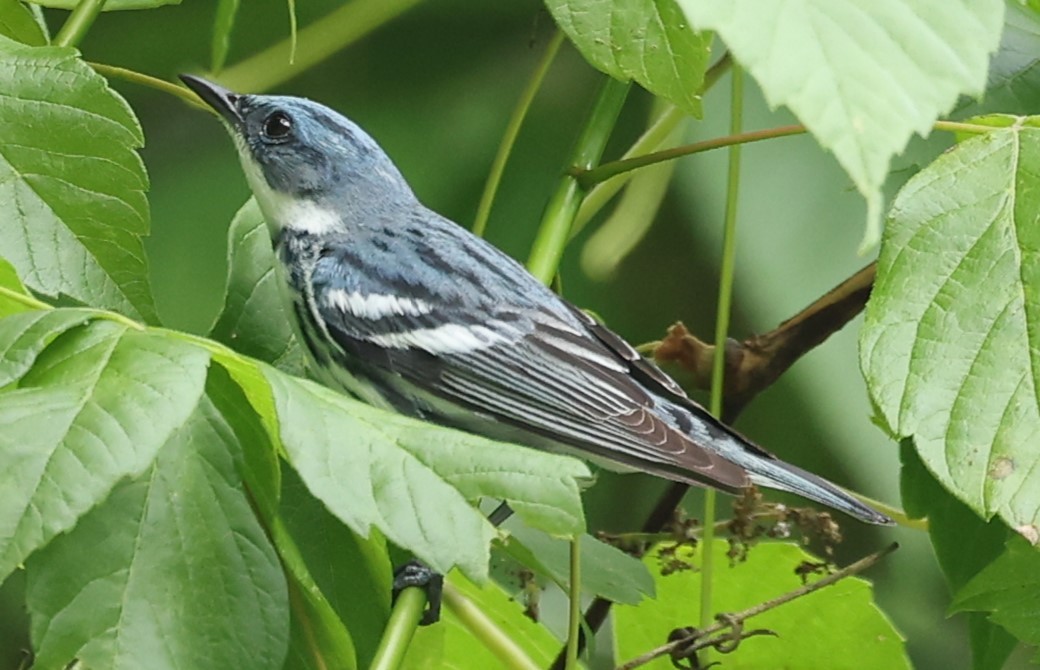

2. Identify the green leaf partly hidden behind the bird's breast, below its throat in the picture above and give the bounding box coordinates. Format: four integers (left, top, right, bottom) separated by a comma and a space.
210, 198, 305, 377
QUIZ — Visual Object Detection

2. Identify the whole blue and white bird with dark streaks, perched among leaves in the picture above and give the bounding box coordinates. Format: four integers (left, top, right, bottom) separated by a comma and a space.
182, 71, 891, 523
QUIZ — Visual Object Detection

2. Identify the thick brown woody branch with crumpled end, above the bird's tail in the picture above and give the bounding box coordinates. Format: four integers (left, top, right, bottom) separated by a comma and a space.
653, 263, 877, 421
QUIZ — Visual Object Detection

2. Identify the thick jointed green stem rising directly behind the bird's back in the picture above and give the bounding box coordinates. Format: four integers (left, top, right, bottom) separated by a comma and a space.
527, 77, 629, 284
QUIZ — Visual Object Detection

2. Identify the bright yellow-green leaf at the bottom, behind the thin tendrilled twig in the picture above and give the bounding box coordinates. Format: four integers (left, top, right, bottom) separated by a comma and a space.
614, 540, 911, 670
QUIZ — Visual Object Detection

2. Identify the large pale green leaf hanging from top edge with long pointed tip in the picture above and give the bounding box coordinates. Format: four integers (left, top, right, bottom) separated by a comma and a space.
677, 0, 1004, 246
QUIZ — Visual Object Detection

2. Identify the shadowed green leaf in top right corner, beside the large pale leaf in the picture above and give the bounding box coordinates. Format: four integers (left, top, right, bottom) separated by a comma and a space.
957, 2, 1040, 117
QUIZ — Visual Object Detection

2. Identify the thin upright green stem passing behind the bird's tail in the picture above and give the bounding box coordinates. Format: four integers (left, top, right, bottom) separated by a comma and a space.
701, 67, 744, 627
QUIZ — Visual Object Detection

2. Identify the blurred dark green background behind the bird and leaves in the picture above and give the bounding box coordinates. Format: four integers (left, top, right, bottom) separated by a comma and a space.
0, 0, 985, 668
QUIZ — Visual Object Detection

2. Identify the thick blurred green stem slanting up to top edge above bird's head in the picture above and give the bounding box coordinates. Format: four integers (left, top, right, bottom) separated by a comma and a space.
220, 0, 420, 93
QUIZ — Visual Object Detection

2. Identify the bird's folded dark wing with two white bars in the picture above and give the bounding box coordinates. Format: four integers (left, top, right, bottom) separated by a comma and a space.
316, 280, 748, 490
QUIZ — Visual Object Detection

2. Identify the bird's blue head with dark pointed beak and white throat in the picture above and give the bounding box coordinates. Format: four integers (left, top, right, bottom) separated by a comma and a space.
181, 75, 414, 232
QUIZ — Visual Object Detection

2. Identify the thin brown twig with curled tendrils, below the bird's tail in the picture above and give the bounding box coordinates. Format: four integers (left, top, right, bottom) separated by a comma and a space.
618, 542, 900, 670
